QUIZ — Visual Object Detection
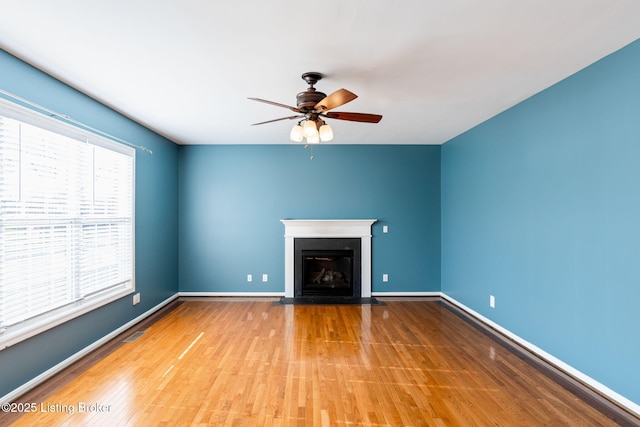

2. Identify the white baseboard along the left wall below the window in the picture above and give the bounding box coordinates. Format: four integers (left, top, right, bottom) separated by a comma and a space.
0, 294, 178, 404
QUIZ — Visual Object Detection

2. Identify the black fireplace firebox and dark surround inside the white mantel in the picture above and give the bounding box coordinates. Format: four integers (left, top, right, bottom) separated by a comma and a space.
294, 238, 362, 297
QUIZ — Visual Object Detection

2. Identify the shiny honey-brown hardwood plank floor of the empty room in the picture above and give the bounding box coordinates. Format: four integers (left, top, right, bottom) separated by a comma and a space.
0, 299, 636, 426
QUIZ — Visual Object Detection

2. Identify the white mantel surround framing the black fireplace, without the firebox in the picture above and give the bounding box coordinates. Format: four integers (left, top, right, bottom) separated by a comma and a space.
280, 219, 377, 298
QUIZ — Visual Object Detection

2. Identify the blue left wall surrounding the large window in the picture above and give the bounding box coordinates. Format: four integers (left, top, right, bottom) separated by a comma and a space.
0, 50, 178, 397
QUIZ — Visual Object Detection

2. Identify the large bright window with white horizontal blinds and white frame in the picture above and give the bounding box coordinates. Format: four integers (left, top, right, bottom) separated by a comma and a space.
0, 100, 135, 349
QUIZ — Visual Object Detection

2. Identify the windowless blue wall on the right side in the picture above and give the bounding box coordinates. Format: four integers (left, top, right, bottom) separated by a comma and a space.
442, 41, 640, 402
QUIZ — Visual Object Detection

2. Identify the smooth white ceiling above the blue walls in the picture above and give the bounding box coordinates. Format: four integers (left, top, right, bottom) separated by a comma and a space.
0, 0, 640, 144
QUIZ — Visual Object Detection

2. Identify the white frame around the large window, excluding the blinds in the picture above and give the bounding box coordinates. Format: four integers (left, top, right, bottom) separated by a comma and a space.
0, 98, 136, 351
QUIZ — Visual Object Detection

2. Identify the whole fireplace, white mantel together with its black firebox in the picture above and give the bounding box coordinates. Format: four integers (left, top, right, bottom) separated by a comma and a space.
281, 219, 376, 298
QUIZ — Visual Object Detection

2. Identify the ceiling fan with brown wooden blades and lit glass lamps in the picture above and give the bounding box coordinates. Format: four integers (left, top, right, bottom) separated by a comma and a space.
249, 72, 382, 143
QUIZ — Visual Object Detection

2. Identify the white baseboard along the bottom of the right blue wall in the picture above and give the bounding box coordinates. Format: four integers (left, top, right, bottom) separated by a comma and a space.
442, 293, 640, 417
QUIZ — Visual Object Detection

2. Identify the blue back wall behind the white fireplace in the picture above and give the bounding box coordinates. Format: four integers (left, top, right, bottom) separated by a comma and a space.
179, 144, 440, 292
